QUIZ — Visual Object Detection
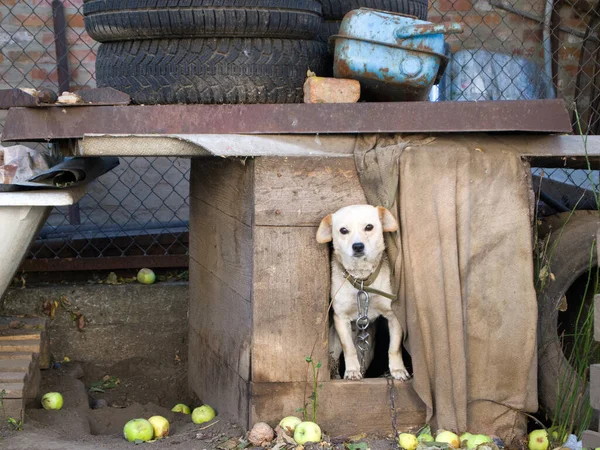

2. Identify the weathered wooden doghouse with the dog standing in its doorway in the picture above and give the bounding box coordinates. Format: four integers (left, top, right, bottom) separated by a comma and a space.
189, 154, 425, 435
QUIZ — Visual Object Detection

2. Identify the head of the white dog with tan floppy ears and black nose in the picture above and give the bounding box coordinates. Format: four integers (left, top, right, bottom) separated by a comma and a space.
317, 205, 398, 268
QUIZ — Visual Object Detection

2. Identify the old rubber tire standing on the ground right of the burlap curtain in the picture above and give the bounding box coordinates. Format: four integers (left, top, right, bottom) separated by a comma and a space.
538, 211, 599, 417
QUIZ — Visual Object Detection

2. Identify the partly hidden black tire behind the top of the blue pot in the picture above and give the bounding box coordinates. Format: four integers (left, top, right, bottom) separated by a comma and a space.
321, 0, 428, 20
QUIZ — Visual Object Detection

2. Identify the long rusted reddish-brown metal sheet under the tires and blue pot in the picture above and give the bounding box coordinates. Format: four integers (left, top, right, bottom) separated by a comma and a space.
2, 100, 572, 142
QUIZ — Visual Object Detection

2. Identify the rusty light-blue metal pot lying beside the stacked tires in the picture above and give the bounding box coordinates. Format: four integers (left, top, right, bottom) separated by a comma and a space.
331, 8, 462, 101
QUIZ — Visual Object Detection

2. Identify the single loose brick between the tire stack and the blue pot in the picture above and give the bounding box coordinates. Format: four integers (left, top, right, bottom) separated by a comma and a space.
304, 77, 360, 103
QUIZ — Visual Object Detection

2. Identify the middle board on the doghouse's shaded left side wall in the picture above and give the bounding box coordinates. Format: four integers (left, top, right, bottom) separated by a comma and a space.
188, 258, 252, 380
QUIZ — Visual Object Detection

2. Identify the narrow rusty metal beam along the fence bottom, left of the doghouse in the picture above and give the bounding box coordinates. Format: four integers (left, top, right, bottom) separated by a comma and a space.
21, 255, 189, 272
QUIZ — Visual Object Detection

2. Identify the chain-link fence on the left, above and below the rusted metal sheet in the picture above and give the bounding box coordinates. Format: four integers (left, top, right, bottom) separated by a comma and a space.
0, 0, 190, 270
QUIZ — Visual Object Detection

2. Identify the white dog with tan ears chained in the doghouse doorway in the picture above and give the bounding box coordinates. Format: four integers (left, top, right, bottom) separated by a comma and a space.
317, 205, 410, 380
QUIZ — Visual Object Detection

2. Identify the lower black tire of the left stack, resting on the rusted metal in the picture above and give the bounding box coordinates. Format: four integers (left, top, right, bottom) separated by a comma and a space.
96, 38, 327, 105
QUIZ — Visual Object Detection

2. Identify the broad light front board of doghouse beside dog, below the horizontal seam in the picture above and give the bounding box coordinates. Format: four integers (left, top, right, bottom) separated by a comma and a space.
252, 227, 330, 382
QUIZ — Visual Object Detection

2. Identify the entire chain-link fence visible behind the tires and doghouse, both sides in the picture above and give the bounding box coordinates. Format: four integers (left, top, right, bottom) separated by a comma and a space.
0, 0, 600, 270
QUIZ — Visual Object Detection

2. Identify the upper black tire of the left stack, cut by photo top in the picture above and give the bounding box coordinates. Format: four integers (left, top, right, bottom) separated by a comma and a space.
83, 0, 322, 42
